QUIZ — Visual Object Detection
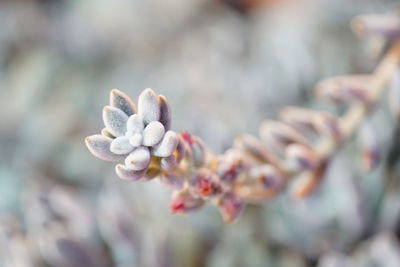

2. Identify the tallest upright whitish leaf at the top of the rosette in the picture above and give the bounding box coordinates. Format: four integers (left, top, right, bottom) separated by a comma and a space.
138, 88, 160, 124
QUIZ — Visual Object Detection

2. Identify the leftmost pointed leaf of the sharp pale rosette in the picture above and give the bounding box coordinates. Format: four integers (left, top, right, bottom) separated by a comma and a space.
85, 134, 124, 162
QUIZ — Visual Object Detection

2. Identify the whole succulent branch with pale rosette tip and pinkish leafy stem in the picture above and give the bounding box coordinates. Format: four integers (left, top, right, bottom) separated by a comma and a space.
86, 14, 400, 226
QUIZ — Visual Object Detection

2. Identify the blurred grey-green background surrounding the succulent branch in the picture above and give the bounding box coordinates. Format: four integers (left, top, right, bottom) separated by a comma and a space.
0, 0, 400, 267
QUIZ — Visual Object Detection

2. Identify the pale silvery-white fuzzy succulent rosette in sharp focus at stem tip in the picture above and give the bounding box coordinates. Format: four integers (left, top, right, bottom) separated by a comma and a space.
85, 89, 179, 180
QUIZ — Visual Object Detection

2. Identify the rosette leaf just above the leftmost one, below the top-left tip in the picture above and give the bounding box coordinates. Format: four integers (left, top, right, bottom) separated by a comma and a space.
103, 106, 128, 137
